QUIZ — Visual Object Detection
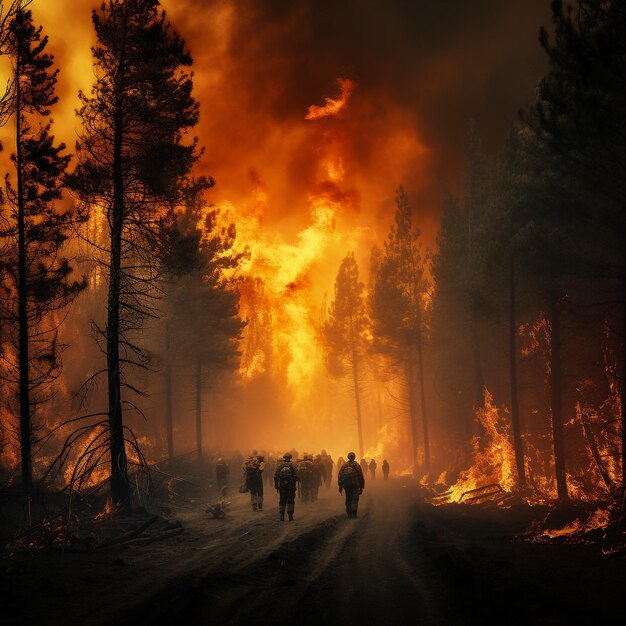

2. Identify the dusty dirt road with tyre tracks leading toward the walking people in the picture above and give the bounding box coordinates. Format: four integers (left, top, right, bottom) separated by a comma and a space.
117, 484, 438, 624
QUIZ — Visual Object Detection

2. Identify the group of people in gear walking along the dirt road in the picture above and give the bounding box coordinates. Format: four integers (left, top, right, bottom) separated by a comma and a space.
215, 450, 390, 521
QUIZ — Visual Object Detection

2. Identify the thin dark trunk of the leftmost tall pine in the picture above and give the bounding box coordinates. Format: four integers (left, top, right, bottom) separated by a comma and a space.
15, 41, 33, 494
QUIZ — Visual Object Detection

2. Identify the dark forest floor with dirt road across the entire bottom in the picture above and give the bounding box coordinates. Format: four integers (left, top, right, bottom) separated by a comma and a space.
0, 479, 626, 626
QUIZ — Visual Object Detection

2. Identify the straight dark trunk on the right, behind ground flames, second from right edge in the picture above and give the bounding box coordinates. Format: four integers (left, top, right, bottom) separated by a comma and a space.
550, 298, 568, 501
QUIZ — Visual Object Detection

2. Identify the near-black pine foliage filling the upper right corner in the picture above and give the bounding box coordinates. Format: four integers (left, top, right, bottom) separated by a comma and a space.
522, 0, 626, 484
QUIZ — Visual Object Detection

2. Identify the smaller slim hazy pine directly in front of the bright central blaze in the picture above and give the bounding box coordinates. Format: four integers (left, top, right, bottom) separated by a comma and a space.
323, 253, 368, 458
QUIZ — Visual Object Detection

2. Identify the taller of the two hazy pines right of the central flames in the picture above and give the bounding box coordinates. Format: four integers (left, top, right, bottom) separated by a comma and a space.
370, 187, 430, 473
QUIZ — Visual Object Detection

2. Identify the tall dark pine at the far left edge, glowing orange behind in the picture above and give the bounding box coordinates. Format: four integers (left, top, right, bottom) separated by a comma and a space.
0, 9, 86, 492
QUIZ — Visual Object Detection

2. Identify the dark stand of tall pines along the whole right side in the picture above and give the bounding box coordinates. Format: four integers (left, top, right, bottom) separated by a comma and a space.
434, 0, 626, 500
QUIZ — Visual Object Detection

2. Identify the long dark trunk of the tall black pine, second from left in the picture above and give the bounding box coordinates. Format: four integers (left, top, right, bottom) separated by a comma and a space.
106, 97, 130, 508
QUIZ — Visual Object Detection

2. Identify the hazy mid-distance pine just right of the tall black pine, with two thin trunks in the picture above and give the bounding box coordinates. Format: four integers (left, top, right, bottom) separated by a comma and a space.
164, 193, 245, 459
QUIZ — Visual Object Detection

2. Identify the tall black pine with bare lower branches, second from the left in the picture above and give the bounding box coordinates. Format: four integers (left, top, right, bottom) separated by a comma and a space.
71, 0, 199, 505
